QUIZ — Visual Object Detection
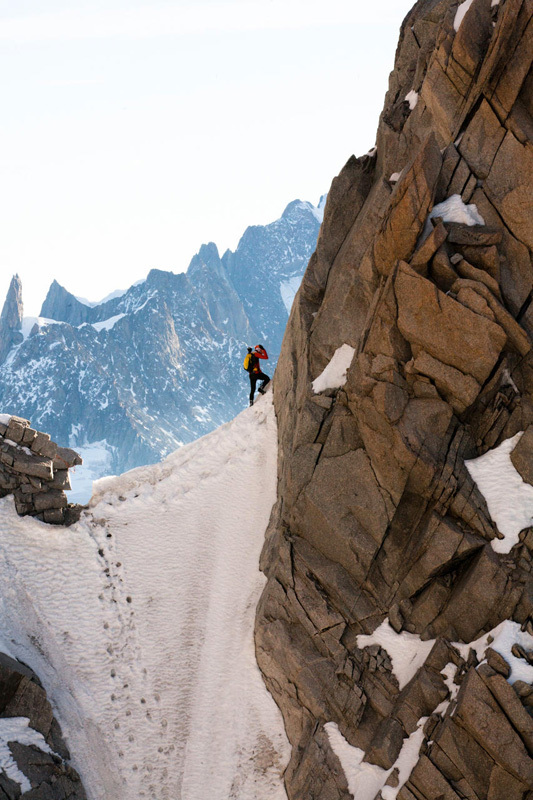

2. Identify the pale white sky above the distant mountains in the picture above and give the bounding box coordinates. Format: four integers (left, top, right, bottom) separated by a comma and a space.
0, 0, 412, 316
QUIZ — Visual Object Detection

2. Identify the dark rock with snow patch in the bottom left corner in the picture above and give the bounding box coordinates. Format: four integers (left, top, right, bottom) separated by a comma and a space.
0, 653, 86, 800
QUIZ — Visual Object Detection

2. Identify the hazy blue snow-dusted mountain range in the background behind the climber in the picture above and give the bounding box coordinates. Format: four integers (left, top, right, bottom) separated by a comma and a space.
0, 199, 324, 500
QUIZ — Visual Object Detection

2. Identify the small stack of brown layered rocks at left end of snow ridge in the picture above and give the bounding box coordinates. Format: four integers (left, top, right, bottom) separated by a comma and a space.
0, 414, 82, 525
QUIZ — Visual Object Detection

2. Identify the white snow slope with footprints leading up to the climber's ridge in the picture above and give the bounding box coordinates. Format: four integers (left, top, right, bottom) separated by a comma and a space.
0, 394, 289, 800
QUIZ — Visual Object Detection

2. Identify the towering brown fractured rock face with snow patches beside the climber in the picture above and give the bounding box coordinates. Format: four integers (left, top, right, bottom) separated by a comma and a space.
256, 0, 533, 800
